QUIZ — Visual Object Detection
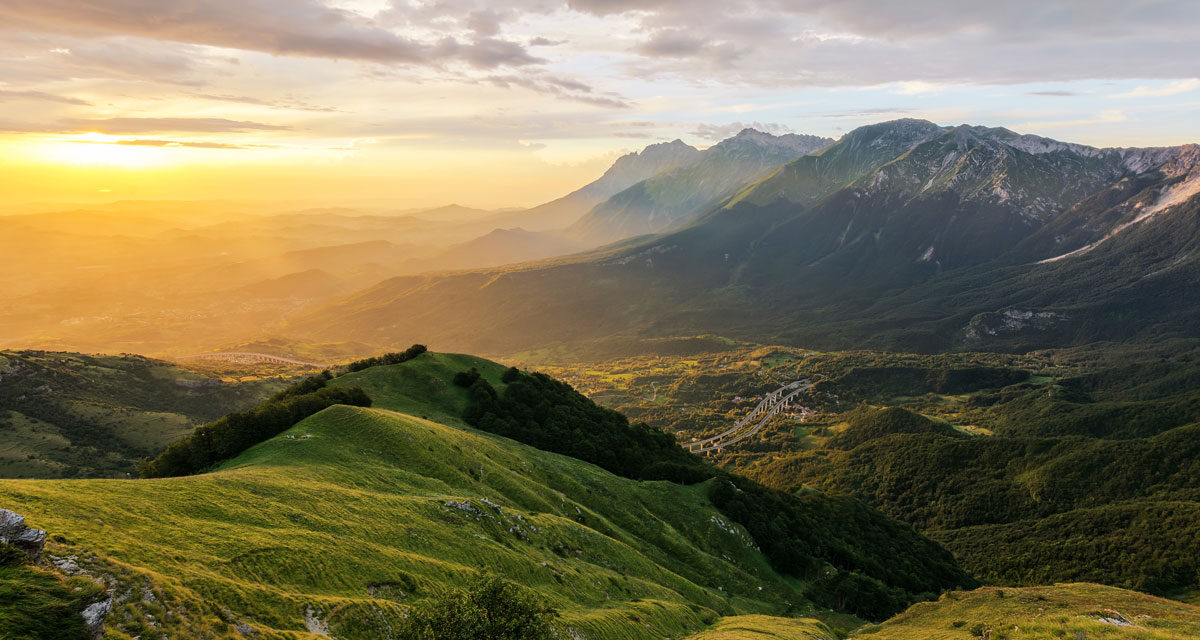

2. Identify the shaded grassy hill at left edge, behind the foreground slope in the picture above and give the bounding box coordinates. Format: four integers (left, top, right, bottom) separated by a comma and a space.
0, 351, 284, 478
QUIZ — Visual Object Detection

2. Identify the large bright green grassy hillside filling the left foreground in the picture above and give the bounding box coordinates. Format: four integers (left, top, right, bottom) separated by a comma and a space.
0, 354, 825, 639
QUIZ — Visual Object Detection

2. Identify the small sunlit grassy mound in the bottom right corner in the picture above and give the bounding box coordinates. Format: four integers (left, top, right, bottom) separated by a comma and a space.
853, 584, 1200, 640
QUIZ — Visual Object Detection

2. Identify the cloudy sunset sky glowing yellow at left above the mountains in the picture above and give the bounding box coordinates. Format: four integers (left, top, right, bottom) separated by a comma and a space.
0, 0, 1200, 208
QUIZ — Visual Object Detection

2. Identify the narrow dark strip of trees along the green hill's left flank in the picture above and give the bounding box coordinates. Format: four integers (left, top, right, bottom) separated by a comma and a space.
138, 383, 371, 478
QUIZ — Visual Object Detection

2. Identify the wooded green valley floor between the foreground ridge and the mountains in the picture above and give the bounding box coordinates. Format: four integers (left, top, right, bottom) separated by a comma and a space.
535, 342, 1200, 598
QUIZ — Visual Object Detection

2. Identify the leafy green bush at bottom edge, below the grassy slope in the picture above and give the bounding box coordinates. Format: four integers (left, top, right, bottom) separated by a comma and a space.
400, 575, 558, 640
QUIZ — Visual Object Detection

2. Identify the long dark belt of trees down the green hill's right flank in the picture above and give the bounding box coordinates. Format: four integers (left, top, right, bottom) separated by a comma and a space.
463, 369, 973, 620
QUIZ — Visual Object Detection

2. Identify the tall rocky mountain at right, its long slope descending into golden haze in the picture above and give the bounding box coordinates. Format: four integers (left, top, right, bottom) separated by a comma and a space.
288, 119, 1200, 353
